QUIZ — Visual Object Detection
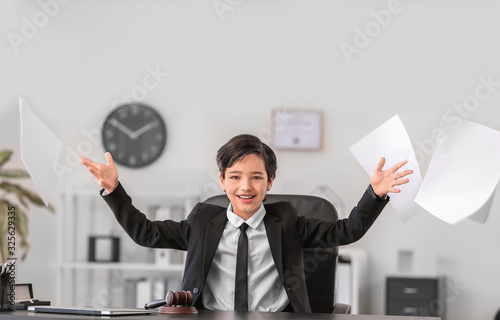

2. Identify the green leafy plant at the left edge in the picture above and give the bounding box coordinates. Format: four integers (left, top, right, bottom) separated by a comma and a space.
0, 150, 54, 263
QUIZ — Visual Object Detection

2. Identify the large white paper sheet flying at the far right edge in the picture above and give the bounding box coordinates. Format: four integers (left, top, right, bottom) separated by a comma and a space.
415, 118, 500, 224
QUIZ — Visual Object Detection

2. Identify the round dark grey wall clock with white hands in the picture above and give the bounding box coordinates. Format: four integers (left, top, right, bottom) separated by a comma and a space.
102, 103, 167, 168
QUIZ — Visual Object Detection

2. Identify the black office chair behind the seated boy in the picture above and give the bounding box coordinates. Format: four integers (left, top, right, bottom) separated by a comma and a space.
205, 194, 351, 314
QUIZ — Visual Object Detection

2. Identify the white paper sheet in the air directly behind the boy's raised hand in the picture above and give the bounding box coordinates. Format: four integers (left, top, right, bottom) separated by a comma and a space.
349, 115, 422, 222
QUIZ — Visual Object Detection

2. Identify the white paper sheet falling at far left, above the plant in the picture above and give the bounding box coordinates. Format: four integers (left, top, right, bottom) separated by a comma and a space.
19, 97, 62, 206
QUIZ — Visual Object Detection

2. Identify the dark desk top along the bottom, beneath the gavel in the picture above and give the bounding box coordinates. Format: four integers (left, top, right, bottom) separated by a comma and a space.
0, 310, 441, 320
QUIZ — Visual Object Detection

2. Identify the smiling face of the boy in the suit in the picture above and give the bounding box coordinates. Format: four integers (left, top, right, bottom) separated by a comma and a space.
219, 153, 273, 220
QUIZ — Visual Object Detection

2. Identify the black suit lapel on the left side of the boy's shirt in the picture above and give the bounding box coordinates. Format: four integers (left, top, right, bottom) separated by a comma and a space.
203, 209, 227, 281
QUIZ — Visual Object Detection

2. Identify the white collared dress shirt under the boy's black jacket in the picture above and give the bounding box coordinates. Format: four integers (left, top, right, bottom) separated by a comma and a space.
203, 204, 289, 311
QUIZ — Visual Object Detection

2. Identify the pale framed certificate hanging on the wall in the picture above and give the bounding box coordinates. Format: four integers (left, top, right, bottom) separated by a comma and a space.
272, 109, 323, 151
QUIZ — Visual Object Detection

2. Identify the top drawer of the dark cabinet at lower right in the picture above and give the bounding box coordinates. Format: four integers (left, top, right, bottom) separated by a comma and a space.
387, 278, 438, 300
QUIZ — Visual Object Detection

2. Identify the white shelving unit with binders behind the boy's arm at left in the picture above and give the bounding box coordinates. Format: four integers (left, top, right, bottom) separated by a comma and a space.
51, 189, 198, 307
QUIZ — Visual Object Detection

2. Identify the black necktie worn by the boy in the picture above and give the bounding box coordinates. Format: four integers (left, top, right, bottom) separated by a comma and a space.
234, 223, 248, 311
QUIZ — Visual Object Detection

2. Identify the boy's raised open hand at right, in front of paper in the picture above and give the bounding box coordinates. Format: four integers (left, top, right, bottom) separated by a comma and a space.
370, 157, 413, 198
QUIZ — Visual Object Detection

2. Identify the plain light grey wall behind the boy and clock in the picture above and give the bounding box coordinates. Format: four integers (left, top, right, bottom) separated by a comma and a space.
0, 0, 500, 320
